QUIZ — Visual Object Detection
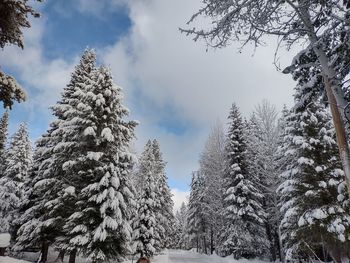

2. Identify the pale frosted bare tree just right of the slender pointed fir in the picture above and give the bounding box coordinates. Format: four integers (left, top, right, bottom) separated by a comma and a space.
246, 100, 279, 261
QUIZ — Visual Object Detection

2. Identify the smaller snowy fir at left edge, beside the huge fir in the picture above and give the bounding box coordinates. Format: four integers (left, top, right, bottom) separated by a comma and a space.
0, 123, 32, 239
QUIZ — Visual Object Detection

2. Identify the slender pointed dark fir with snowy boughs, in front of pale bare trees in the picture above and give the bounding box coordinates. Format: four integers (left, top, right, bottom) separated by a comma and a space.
218, 104, 267, 259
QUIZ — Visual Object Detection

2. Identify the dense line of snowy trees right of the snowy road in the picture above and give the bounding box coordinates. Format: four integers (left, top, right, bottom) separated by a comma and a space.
178, 97, 350, 262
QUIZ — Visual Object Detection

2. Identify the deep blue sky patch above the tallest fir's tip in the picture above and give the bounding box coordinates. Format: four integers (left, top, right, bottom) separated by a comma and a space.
41, 0, 131, 59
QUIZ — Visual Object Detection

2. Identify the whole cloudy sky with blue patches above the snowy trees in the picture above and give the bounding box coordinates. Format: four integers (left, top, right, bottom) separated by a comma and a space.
0, 0, 294, 210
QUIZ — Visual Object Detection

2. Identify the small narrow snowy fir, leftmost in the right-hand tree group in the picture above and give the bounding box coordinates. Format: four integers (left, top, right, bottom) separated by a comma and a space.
187, 171, 208, 254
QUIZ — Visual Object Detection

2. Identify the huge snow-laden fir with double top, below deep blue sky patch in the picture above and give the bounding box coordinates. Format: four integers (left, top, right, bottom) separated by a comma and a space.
19, 50, 136, 262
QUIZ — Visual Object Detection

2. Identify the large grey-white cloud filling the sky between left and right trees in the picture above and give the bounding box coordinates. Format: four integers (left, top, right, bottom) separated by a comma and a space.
103, 0, 294, 190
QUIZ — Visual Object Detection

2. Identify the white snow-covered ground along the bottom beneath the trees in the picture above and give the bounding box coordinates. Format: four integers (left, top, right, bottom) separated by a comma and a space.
0, 250, 263, 263
